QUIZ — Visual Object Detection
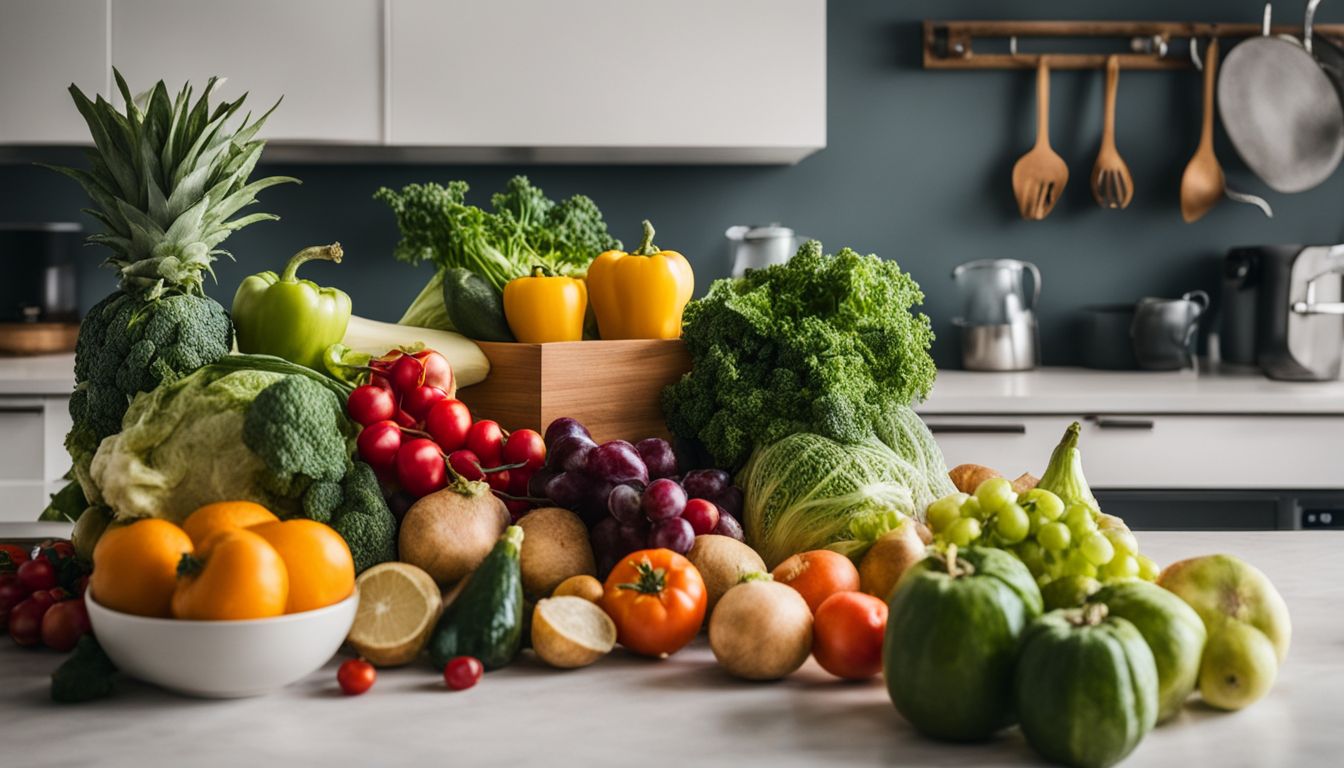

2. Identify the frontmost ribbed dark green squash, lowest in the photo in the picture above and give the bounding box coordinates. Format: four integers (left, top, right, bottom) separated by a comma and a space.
1013, 603, 1157, 768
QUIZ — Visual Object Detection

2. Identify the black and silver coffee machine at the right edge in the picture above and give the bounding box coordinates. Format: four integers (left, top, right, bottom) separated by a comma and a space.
1219, 245, 1344, 381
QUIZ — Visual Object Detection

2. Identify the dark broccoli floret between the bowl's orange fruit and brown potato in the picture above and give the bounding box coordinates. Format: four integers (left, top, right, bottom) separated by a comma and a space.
304, 461, 396, 573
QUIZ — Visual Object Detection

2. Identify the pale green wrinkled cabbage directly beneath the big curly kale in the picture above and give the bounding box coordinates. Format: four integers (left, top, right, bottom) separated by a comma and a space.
737, 432, 925, 568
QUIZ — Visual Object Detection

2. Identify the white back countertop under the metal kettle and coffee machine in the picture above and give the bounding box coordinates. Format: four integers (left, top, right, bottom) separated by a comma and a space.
915, 367, 1344, 414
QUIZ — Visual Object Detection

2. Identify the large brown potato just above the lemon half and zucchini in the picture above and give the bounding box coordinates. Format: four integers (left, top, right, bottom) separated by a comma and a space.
398, 483, 508, 588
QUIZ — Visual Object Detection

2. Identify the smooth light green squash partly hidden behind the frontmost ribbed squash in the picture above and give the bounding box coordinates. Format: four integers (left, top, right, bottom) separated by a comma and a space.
1089, 581, 1207, 722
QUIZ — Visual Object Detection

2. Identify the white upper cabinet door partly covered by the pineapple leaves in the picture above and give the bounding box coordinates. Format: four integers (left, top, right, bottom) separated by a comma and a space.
112, 0, 383, 144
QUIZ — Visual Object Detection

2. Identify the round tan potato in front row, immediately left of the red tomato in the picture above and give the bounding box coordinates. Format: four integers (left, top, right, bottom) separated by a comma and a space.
710, 580, 812, 681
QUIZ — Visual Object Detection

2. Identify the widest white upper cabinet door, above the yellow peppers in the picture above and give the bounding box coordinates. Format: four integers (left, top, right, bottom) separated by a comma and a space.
390, 0, 827, 160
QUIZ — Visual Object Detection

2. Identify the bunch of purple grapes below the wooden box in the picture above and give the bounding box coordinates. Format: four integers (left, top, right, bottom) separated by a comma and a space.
528, 418, 743, 574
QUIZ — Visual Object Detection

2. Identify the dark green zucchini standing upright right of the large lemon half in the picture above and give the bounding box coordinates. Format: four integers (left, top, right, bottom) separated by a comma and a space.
429, 526, 523, 670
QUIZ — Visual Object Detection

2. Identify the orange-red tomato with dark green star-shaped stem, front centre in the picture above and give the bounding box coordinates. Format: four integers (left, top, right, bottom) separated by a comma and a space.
602, 549, 707, 656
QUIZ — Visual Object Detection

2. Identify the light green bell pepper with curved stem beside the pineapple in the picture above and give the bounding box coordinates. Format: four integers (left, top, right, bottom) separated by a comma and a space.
234, 242, 351, 371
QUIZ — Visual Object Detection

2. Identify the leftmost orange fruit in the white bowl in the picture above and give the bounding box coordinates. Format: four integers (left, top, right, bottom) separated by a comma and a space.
89, 519, 192, 619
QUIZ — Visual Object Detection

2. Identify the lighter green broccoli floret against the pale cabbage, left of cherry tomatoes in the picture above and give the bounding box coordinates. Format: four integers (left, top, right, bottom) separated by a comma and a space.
243, 375, 349, 498
